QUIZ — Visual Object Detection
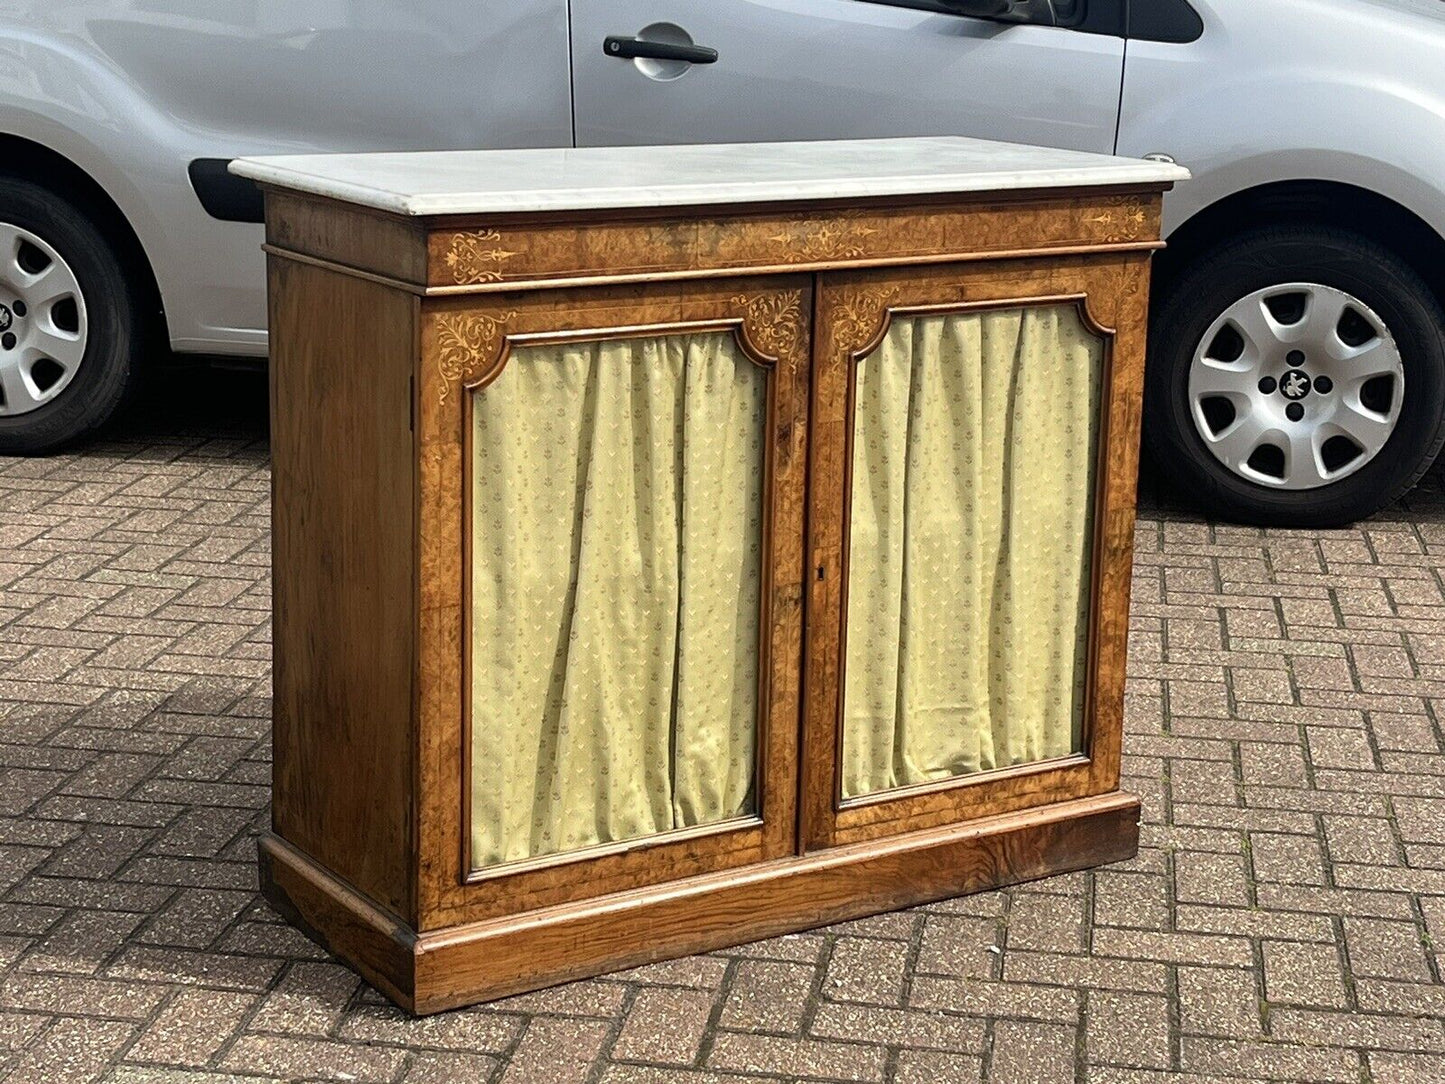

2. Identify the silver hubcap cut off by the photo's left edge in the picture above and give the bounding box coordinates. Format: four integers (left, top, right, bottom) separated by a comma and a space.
0, 223, 88, 416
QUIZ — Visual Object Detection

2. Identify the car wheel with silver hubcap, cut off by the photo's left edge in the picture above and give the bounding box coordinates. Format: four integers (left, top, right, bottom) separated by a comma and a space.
0, 178, 143, 455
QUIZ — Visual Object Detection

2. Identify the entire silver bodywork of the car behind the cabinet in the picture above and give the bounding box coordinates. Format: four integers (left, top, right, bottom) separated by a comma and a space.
0, 0, 1445, 354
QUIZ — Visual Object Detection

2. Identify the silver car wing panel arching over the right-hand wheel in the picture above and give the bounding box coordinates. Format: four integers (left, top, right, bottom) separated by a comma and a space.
1117, 0, 1445, 244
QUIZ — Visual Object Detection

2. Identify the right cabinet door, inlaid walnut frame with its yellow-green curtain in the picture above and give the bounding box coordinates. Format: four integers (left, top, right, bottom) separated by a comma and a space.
802, 254, 1147, 848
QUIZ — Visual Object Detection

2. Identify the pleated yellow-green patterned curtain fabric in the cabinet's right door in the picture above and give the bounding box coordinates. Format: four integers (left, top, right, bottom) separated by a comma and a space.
842, 305, 1104, 796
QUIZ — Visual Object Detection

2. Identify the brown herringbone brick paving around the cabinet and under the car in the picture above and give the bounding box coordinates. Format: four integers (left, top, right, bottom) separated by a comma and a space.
0, 367, 1445, 1084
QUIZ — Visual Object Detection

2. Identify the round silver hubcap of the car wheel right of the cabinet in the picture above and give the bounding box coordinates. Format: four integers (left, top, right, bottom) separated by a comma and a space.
1189, 282, 1405, 490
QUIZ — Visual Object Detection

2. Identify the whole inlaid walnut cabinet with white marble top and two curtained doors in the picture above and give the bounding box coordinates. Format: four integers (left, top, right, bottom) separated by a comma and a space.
237, 140, 1182, 1012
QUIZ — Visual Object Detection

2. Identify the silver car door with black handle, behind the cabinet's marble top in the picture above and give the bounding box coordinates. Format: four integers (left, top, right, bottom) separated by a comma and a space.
572, 0, 1124, 152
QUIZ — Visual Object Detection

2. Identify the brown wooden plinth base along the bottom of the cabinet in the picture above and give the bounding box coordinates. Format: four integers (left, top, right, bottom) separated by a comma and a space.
259, 792, 1140, 1013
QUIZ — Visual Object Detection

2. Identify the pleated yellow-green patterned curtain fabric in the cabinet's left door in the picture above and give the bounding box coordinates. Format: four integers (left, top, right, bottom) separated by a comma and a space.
471, 332, 767, 869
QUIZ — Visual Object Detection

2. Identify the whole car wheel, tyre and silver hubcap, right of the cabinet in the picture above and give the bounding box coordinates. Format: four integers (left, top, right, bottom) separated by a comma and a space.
1144, 227, 1445, 526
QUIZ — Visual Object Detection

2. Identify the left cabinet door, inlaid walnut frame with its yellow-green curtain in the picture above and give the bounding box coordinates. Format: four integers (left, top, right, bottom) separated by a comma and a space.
416, 276, 812, 925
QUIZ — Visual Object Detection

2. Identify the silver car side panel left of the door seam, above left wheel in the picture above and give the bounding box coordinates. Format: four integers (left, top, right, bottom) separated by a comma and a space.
0, 0, 572, 354
